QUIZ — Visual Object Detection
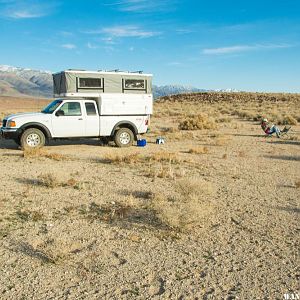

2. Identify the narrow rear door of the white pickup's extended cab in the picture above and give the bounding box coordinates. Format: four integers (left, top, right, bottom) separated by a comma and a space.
84, 101, 100, 137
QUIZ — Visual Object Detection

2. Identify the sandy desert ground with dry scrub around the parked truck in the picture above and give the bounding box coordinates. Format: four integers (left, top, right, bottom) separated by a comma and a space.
0, 93, 300, 299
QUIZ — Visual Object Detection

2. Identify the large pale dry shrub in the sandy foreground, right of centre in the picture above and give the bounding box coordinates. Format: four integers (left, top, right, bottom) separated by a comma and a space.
151, 179, 214, 231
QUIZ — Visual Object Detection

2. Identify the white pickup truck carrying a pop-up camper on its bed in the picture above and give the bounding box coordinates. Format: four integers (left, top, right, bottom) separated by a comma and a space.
1, 70, 153, 148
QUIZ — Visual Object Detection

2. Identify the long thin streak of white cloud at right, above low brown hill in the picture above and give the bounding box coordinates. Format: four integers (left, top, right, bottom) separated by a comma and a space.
202, 44, 291, 55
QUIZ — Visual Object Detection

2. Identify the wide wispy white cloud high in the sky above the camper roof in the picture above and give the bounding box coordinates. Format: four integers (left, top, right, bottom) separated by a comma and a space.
85, 25, 160, 38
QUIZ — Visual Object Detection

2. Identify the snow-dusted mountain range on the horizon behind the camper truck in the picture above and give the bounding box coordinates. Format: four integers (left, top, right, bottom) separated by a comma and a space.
0, 65, 239, 98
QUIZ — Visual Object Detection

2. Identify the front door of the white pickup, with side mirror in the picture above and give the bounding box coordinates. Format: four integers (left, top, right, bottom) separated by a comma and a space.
52, 100, 85, 137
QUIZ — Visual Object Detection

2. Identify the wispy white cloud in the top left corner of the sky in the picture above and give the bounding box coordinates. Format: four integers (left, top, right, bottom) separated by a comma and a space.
0, 0, 58, 19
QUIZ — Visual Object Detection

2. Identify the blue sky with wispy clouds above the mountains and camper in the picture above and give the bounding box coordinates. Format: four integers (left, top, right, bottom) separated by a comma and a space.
0, 0, 300, 92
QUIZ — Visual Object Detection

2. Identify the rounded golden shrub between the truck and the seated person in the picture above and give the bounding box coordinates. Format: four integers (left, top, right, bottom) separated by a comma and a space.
178, 114, 217, 130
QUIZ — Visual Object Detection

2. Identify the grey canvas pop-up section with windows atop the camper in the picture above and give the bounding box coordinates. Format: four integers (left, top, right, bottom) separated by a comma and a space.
53, 70, 152, 97
